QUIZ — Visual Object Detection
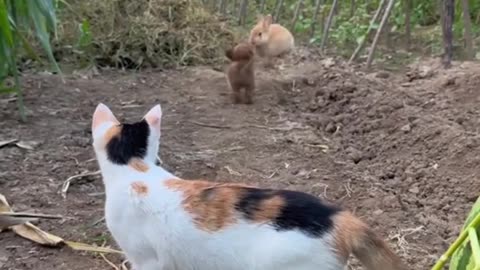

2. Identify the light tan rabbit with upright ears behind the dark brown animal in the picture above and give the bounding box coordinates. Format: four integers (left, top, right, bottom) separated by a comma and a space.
249, 15, 295, 65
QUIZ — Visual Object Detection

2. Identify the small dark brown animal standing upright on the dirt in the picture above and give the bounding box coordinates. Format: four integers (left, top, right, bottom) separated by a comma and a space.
225, 42, 255, 104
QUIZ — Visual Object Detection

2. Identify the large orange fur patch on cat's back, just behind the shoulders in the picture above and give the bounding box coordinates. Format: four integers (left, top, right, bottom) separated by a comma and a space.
165, 179, 251, 232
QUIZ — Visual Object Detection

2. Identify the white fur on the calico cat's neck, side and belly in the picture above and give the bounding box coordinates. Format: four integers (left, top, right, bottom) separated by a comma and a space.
93, 104, 344, 270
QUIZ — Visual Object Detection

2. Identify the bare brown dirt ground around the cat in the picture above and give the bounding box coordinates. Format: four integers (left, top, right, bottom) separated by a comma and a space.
0, 51, 480, 270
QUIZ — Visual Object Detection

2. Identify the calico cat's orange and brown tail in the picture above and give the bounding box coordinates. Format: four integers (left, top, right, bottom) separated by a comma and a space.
334, 211, 406, 270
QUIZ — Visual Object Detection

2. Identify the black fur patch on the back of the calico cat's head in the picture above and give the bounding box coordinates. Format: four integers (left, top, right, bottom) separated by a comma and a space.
107, 120, 150, 165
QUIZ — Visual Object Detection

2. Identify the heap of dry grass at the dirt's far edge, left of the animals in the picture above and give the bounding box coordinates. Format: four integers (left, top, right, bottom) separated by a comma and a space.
57, 0, 236, 68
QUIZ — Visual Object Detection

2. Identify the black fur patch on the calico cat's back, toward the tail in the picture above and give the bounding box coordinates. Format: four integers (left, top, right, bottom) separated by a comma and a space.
236, 188, 340, 237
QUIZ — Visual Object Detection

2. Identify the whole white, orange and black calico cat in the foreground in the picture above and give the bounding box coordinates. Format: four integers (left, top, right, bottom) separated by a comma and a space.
92, 104, 405, 270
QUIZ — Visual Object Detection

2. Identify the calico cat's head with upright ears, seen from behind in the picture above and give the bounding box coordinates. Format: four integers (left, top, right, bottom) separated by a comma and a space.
92, 103, 162, 165
